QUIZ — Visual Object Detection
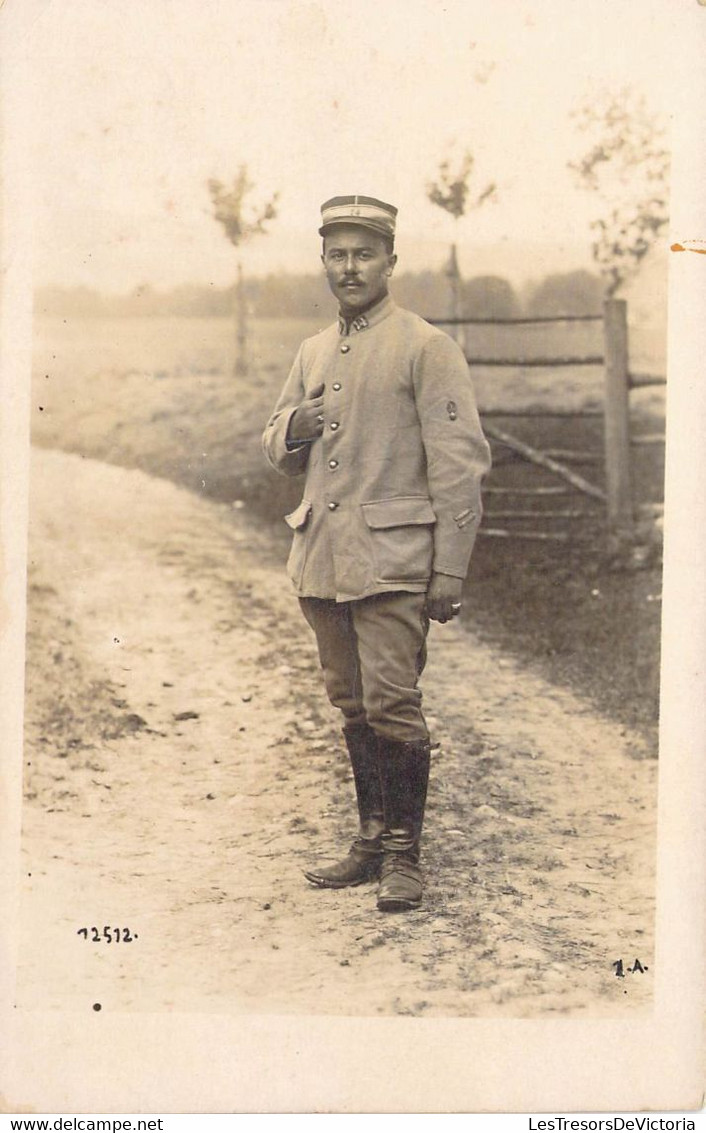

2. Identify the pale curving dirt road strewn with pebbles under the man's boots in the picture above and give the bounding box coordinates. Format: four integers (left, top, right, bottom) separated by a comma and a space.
17, 451, 656, 1017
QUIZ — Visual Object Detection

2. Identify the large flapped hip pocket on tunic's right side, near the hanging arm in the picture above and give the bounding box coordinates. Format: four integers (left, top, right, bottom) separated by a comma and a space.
360, 496, 436, 582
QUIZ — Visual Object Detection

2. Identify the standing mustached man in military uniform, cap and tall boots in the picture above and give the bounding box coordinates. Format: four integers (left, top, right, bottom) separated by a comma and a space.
263, 196, 490, 911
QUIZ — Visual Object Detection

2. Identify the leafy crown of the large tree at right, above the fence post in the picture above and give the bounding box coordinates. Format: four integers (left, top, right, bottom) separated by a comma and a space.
569, 87, 670, 298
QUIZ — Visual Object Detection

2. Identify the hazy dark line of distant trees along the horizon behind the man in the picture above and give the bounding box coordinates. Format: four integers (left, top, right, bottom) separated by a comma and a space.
35, 270, 604, 318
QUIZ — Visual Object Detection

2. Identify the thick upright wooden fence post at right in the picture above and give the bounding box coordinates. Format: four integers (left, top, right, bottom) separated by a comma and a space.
603, 299, 633, 552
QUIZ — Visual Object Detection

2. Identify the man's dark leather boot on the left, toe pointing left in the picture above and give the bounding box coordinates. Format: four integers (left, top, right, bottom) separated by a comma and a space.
304, 724, 385, 889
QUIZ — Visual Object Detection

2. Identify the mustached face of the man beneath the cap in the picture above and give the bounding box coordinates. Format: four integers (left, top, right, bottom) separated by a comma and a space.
322, 224, 397, 315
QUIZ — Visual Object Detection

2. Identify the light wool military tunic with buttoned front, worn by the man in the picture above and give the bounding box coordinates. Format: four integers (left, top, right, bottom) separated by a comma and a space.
263, 296, 490, 603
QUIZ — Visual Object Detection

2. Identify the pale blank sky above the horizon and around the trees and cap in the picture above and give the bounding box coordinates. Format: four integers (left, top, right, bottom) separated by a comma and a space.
10, 0, 693, 290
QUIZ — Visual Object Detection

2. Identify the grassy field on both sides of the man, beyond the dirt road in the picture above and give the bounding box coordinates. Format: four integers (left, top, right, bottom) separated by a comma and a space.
33, 318, 664, 739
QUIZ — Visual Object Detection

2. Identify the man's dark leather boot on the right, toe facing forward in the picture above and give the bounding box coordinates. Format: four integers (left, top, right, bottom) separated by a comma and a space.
377, 736, 429, 912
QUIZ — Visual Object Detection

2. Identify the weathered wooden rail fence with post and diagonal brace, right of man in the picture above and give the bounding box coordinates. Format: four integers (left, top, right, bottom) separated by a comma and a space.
429, 299, 665, 547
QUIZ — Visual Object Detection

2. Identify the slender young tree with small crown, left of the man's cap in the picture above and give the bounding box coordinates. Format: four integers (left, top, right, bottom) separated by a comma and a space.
209, 165, 280, 375
